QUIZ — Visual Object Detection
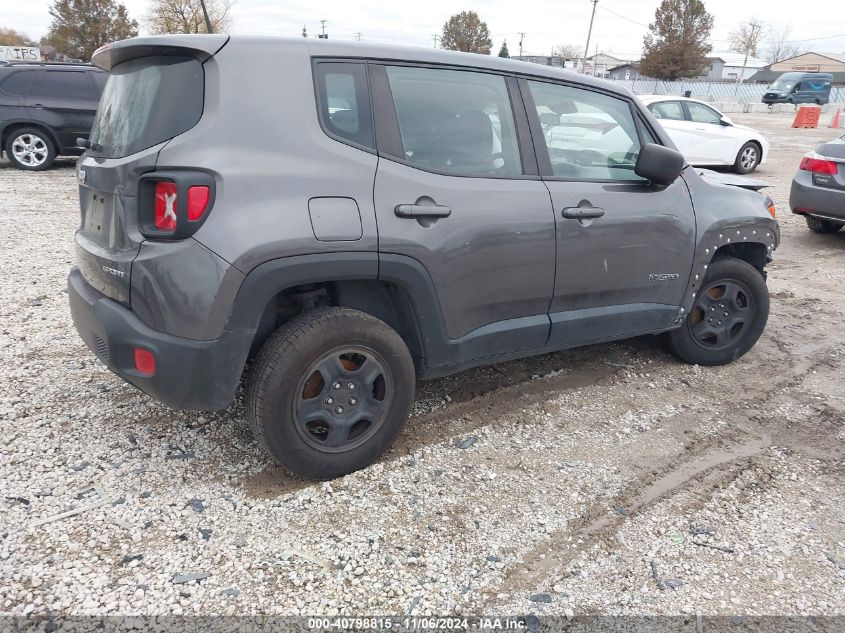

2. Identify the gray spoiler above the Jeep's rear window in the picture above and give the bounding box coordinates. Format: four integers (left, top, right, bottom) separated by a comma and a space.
91, 33, 229, 71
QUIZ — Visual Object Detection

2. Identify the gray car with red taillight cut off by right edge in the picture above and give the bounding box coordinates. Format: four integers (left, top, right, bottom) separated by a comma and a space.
789, 135, 845, 233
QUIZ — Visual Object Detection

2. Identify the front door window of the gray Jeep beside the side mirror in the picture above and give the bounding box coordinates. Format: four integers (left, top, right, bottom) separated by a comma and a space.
528, 81, 643, 181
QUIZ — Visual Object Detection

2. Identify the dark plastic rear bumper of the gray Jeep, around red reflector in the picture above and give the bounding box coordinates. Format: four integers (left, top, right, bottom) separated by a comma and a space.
68, 268, 253, 409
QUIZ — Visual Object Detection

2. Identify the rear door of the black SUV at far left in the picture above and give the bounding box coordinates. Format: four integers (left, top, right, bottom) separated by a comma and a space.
26, 67, 99, 153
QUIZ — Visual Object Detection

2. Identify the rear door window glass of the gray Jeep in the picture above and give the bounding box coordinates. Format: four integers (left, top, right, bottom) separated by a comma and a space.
386, 66, 522, 178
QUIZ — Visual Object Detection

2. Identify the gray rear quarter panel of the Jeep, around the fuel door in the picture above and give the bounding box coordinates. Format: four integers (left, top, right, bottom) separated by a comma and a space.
157, 37, 378, 274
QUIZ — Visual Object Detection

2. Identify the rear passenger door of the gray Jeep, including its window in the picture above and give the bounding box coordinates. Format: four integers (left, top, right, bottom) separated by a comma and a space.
370, 64, 555, 363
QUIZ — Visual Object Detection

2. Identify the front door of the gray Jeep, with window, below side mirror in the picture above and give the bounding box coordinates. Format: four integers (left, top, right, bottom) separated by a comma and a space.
521, 81, 695, 347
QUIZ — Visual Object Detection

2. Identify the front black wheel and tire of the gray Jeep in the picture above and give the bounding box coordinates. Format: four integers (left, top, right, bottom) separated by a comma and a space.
669, 257, 769, 365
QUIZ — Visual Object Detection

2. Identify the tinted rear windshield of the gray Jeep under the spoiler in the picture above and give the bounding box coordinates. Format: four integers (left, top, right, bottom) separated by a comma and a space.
91, 57, 205, 158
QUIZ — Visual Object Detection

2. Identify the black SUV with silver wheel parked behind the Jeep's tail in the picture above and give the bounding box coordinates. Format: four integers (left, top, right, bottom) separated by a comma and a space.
0, 62, 108, 171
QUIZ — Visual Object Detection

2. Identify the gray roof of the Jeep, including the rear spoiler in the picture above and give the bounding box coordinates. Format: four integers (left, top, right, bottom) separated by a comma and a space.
93, 34, 631, 96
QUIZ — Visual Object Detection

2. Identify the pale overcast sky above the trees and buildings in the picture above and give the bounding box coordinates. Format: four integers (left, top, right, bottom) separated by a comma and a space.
6, 0, 845, 58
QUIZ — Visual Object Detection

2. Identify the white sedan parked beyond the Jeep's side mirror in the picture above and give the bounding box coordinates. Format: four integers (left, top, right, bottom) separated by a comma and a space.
640, 95, 769, 174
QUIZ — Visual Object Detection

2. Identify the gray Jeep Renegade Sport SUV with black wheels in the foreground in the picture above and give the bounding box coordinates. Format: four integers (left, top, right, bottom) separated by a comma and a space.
68, 35, 779, 479
